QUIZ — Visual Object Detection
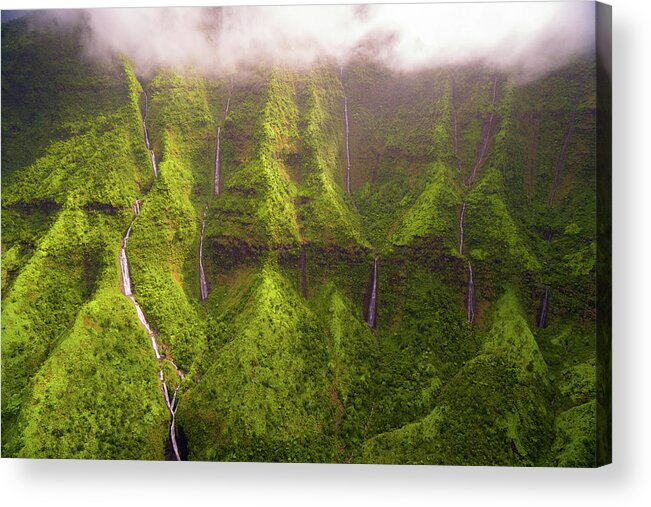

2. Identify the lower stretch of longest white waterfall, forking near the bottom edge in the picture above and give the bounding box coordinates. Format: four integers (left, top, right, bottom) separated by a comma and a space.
119, 201, 183, 461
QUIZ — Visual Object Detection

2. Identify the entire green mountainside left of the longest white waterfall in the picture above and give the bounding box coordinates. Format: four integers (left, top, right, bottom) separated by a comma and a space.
2, 30, 166, 458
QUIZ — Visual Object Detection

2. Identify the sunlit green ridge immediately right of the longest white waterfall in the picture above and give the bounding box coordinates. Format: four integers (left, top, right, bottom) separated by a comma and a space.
128, 69, 209, 371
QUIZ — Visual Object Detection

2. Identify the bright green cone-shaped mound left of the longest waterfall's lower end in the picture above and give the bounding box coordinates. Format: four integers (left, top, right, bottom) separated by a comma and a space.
18, 286, 169, 459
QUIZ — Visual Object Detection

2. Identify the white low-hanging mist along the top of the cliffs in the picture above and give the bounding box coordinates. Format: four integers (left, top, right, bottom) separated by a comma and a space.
16, 2, 594, 79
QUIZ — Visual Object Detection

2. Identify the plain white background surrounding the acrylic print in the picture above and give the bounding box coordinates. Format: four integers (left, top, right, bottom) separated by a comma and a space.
0, 0, 651, 507
